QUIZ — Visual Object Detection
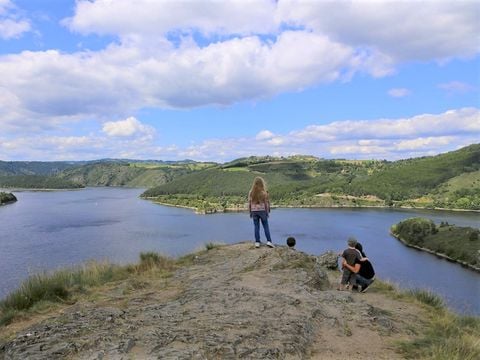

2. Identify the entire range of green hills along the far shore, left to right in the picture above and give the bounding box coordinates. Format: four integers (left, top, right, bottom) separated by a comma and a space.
0, 144, 480, 212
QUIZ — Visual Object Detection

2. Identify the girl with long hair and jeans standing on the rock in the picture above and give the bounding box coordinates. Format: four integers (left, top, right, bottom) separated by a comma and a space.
248, 177, 274, 248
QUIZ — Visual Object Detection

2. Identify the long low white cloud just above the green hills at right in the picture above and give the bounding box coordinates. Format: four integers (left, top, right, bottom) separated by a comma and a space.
171, 108, 480, 161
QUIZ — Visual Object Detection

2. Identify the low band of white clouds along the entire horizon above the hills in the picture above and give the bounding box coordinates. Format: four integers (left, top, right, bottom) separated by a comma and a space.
0, 108, 480, 161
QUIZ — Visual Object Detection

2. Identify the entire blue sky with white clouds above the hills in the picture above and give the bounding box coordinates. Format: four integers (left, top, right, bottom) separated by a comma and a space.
0, 0, 480, 162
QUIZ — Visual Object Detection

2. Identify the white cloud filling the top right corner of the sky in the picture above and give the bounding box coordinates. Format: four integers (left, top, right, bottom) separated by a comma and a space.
278, 0, 480, 61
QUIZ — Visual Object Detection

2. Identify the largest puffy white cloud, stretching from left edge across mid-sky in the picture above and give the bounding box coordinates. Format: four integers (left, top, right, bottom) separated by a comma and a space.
0, 32, 351, 122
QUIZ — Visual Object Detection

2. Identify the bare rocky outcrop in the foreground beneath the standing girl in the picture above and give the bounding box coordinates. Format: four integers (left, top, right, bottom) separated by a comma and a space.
0, 243, 424, 360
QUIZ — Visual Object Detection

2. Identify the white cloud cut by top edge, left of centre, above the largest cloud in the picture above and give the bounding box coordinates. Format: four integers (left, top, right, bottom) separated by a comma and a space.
65, 0, 278, 37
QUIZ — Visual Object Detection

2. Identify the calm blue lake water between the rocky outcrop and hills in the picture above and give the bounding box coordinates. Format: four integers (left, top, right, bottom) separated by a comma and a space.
0, 188, 480, 315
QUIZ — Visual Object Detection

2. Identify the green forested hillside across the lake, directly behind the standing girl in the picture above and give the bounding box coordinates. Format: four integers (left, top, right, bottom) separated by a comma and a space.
143, 144, 480, 210
